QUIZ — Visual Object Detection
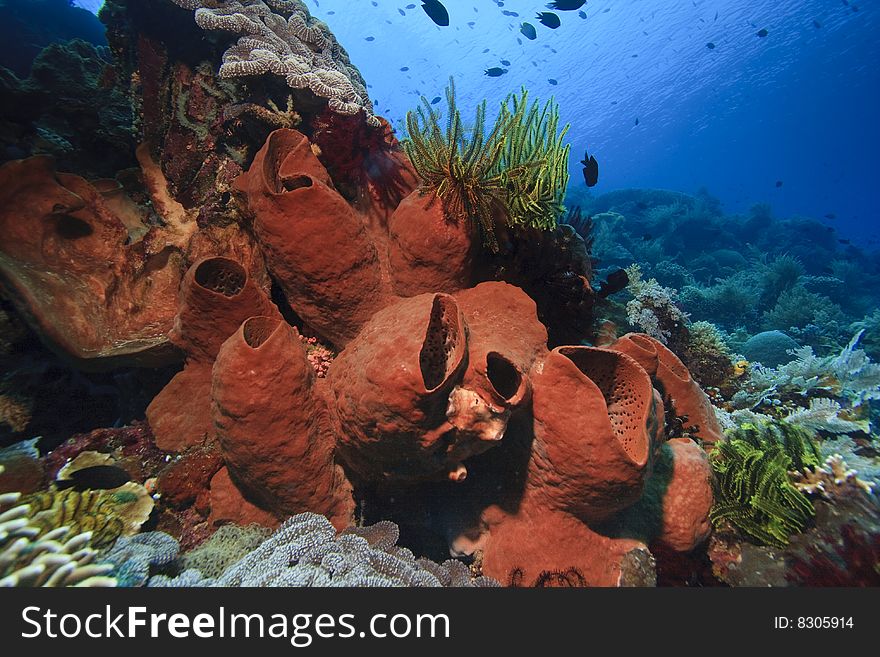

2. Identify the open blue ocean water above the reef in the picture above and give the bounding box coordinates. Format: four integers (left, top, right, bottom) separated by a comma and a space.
77, 0, 880, 247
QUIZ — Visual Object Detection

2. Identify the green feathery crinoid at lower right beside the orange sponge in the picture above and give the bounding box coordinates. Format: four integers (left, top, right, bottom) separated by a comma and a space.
710, 439, 815, 547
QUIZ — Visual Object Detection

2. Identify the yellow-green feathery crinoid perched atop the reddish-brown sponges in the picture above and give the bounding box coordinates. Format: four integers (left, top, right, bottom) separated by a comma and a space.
403, 78, 569, 252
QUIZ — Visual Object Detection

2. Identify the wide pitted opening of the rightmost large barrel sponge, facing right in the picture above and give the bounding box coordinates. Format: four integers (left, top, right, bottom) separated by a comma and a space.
560, 347, 654, 464
